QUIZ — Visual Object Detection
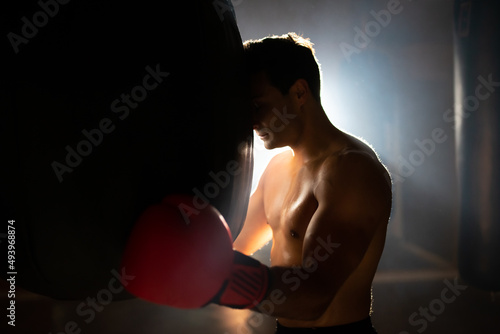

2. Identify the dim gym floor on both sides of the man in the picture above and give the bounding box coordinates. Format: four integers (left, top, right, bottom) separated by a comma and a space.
0, 235, 500, 334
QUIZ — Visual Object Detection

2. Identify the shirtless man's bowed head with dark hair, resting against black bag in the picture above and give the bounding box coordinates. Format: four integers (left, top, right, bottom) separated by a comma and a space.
244, 33, 320, 149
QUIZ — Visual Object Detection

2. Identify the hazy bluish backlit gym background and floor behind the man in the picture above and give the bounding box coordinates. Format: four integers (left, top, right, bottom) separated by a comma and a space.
0, 0, 500, 334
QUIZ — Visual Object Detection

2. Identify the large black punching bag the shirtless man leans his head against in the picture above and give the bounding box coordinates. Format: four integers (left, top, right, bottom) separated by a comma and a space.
0, 0, 253, 299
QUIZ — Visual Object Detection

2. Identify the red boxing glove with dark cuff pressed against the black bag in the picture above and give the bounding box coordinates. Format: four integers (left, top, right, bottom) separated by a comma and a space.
122, 195, 270, 309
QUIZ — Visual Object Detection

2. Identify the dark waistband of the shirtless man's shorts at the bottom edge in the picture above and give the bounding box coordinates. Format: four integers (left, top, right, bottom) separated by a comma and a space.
276, 317, 377, 334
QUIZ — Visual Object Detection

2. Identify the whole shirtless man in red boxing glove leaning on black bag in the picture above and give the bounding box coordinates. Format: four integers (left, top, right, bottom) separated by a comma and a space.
122, 33, 391, 334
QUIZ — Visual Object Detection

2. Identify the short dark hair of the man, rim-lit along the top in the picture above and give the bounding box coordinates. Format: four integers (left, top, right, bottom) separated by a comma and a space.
243, 32, 321, 102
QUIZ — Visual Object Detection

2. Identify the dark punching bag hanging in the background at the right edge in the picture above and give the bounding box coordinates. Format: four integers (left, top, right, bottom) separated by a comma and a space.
455, 0, 500, 291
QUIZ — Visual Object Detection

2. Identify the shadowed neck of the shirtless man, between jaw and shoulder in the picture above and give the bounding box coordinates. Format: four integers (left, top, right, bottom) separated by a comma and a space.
290, 103, 342, 163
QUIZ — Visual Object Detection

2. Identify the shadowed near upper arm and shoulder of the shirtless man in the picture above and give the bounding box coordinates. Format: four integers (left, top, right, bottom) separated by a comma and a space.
303, 153, 391, 297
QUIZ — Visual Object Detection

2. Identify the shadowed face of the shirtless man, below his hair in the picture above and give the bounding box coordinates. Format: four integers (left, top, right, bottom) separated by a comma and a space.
251, 72, 299, 149
